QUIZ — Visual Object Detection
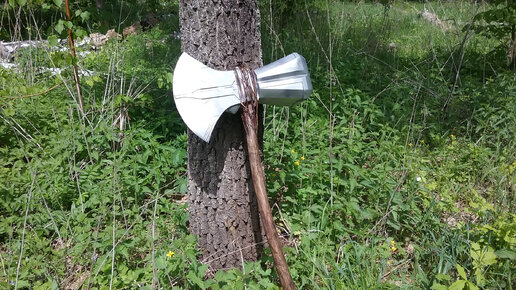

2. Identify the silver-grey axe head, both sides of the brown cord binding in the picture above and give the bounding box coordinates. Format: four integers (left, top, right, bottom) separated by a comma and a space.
173, 53, 312, 142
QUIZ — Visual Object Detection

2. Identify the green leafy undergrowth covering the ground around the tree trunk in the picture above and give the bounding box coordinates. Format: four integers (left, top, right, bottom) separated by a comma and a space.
0, 1, 516, 289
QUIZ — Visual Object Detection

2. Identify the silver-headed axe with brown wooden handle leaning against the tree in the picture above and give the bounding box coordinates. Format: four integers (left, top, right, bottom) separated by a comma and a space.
173, 53, 312, 289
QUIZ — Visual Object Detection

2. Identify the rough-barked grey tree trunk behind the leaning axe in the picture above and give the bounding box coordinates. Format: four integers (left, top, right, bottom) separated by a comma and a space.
180, 0, 263, 270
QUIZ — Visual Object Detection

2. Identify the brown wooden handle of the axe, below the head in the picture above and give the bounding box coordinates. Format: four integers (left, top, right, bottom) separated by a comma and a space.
242, 113, 297, 290
